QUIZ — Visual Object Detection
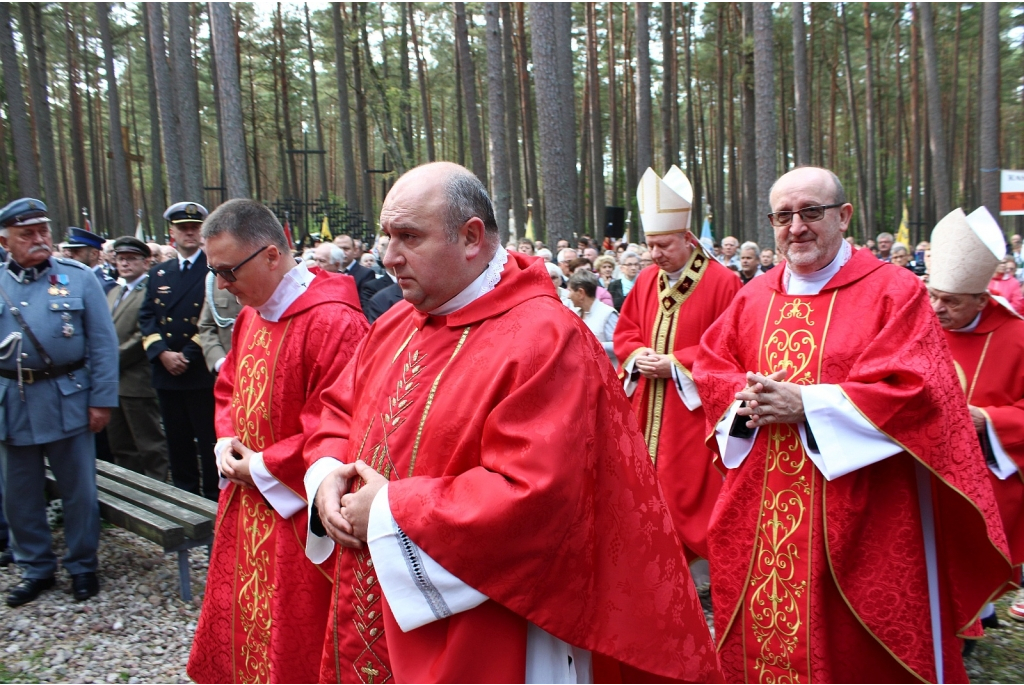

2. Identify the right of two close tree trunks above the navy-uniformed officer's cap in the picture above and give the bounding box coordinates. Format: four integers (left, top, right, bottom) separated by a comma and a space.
164, 2, 204, 202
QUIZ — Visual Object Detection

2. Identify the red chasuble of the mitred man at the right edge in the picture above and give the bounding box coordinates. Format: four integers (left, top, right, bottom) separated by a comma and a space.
946, 301, 1024, 569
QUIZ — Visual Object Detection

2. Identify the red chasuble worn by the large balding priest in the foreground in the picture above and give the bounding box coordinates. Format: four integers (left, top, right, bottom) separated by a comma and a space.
306, 253, 721, 683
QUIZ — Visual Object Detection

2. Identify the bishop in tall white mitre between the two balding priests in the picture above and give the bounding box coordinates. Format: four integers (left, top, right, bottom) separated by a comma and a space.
614, 166, 741, 559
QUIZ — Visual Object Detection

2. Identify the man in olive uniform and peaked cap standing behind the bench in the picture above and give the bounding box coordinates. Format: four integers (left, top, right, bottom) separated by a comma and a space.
106, 237, 167, 482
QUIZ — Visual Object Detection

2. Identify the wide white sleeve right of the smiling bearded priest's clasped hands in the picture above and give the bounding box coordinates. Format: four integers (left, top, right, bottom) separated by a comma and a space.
799, 384, 903, 480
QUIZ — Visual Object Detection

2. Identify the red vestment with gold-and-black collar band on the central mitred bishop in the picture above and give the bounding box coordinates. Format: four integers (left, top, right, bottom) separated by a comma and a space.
615, 249, 741, 557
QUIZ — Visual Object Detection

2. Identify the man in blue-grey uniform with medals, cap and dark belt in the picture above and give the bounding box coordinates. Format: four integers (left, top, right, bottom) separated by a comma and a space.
0, 198, 118, 606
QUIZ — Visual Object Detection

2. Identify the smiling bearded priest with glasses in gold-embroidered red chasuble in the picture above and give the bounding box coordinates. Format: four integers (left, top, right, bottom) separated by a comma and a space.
693, 167, 1010, 683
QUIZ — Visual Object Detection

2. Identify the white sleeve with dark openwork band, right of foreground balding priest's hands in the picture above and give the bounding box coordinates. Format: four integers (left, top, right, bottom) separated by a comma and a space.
367, 485, 487, 633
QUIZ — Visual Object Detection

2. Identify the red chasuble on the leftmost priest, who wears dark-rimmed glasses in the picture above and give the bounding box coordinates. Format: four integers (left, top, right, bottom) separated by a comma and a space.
187, 274, 368, 683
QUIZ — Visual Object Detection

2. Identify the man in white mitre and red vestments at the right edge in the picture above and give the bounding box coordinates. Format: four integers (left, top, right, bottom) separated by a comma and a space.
928, 207, 1024, 627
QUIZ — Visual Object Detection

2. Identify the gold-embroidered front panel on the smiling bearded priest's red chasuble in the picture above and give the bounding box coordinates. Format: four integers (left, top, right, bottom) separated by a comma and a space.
739, 291, 837, 683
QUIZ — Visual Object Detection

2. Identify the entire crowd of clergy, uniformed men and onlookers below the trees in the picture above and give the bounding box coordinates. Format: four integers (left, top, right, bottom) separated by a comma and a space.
0, 156, 1024, 683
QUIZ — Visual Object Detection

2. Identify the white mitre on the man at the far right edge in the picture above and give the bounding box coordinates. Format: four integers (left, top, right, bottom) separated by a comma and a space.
928, 207, 1007, 295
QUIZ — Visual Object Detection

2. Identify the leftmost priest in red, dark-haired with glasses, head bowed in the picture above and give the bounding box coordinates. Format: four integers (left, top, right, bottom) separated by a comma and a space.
188, 200, 368, 683
